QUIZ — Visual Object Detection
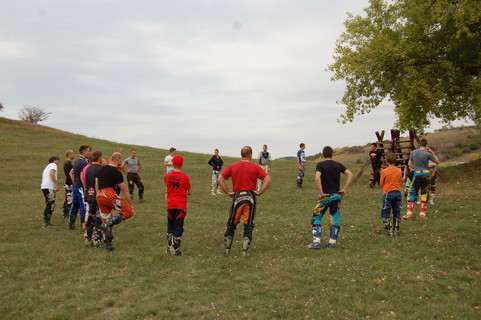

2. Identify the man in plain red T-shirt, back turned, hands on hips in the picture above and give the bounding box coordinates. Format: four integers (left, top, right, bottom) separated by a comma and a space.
218, 146, 272, 257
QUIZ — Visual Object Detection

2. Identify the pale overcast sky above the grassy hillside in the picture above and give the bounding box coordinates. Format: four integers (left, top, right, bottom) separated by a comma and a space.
0, 0, 468, 159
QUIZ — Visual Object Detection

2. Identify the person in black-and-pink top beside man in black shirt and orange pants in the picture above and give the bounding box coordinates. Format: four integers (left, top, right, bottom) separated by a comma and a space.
85, 150, 103, 247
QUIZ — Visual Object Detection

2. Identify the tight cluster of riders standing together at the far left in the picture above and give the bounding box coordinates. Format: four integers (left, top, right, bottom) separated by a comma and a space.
40, 145, 138, 251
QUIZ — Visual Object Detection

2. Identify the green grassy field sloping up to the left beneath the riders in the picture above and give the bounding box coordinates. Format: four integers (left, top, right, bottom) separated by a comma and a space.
0, 118, 481, 320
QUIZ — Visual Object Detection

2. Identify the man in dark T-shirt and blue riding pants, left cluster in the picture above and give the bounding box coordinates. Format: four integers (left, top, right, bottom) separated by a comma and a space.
69, 145, 91, 232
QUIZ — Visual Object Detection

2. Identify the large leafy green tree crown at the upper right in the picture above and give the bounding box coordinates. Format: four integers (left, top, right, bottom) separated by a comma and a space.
328, 0, 481, 132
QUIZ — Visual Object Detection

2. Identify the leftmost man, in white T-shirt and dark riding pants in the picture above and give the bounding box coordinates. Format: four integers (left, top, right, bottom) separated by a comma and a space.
40, 156, 60, 228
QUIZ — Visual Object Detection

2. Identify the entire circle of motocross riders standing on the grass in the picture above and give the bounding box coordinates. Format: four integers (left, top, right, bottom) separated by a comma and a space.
41, 139, 439, 256
